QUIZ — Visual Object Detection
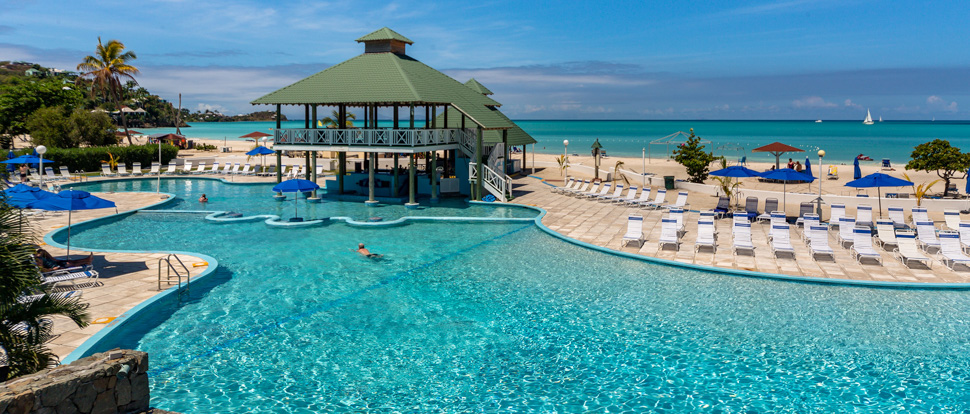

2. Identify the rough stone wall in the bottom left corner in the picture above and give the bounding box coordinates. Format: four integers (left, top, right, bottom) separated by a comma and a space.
0, 349, 149, 414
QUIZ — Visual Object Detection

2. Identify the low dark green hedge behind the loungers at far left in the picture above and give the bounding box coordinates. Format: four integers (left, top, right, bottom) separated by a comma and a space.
35, 144, 178, 171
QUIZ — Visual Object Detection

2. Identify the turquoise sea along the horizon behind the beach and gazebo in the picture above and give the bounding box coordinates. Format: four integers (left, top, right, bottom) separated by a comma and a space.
140, 120, 970, 164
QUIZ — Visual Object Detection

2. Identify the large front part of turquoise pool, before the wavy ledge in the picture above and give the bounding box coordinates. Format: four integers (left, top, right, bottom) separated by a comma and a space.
64, 178, 970, 413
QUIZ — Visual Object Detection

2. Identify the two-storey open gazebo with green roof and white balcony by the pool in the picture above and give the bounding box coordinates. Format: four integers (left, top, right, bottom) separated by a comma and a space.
251, 27, 535, 206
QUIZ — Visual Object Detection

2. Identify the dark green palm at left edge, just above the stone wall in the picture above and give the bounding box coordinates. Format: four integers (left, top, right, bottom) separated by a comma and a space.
0, 200, 88, 381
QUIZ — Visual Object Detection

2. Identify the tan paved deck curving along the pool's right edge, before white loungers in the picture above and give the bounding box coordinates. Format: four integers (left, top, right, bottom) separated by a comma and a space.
514, 177, 970, 283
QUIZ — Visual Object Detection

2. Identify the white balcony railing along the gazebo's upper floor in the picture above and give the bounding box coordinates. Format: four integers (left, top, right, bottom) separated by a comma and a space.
274, 128, 475, 147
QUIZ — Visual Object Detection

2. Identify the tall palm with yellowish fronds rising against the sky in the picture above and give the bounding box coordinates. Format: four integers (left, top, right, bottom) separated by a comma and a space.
77, 36, 138, 145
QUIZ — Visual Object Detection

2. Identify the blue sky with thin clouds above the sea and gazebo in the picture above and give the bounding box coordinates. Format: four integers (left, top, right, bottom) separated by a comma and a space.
0, 0, 970, 120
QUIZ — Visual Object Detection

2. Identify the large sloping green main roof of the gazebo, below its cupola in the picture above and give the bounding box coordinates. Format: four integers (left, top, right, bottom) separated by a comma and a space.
251, 51, 515, 129
